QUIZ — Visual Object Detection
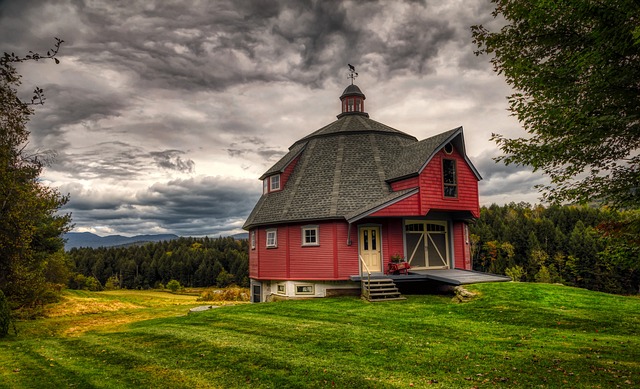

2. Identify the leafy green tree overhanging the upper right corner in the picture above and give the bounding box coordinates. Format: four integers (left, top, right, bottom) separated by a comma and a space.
472, 0, 640, 208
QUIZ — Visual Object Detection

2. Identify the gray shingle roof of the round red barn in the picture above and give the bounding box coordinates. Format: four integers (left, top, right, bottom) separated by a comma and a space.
244, 115, 480, 229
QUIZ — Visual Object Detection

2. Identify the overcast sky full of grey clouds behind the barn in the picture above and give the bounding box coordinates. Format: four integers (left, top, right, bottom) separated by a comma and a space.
0, 0, 542, 236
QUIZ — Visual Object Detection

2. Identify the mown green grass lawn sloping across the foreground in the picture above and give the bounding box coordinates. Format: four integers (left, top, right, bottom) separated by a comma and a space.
0, 283, 640, 388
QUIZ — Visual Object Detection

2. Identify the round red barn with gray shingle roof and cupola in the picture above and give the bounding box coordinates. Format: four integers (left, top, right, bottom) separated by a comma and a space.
244, 81, 481, 302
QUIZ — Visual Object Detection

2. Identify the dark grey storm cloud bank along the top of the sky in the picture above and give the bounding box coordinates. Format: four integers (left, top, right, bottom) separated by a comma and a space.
2, 1, 487, 90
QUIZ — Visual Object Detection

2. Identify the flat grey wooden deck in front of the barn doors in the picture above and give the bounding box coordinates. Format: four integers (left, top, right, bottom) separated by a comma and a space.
350, 269, 511, 285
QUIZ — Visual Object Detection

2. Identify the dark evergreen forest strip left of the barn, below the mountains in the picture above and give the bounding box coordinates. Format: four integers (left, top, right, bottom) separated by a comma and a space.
68, 237, 249, 289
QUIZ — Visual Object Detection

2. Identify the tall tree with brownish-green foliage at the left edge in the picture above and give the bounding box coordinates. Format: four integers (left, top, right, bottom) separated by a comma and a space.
0, 38, 70, 307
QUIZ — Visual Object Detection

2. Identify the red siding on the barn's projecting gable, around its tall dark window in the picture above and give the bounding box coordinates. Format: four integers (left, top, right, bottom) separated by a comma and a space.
420, 149, 480, 217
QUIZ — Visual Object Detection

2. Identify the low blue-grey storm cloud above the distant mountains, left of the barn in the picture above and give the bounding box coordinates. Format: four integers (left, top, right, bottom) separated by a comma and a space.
61, 177, 260, 235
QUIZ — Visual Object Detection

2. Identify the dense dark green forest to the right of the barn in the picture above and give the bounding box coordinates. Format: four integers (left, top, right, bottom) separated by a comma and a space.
470, 203, 640, 294
